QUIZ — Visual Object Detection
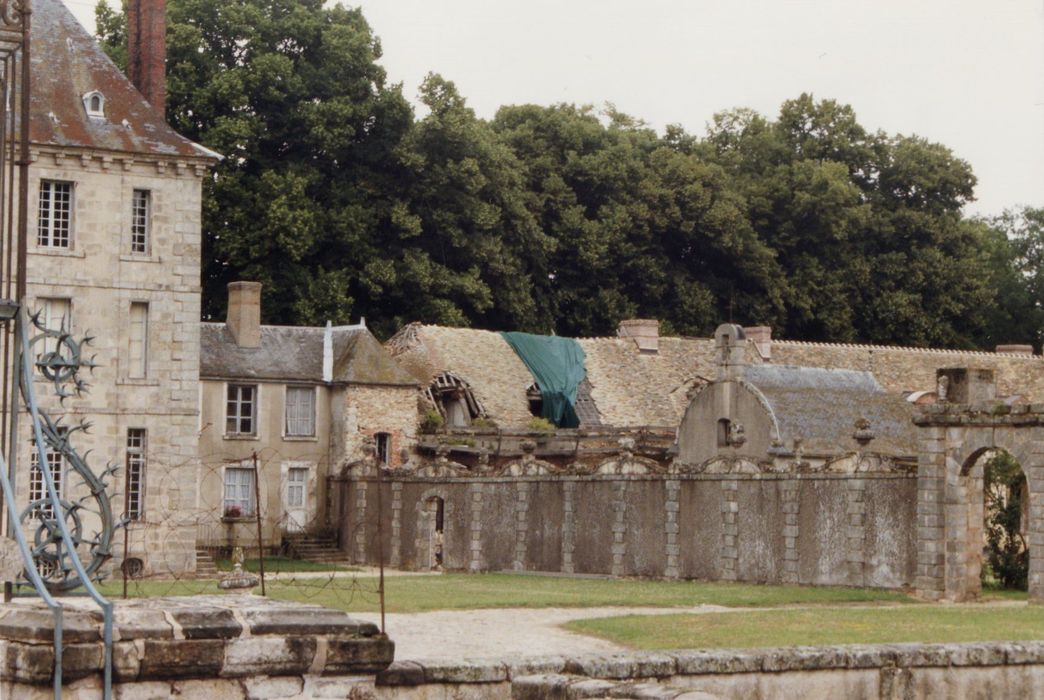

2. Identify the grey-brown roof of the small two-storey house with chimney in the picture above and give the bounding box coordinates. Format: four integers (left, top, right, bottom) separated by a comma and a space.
199, 323, 417, 387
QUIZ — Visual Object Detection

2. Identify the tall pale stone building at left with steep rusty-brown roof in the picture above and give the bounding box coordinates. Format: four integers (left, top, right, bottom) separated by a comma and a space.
18, 0, 216, 573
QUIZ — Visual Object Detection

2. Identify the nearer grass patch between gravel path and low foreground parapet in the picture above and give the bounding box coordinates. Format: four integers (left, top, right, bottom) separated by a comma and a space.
566, 605, 1044, 649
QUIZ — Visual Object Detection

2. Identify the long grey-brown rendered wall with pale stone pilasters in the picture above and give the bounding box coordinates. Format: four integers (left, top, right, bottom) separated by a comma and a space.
334, 473, 917, 588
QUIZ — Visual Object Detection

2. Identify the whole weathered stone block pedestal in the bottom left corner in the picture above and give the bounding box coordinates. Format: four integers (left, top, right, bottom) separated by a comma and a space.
0, 596, 395, 700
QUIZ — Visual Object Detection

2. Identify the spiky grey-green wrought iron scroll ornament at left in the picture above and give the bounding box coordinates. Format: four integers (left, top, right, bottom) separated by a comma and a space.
20, 312, 121, 592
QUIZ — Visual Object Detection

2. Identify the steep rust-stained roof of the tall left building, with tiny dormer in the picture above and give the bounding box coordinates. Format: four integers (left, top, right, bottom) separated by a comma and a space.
27, 0, 218, 159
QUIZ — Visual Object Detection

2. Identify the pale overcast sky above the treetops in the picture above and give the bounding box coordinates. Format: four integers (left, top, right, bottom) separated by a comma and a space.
65, 0, 1044, 215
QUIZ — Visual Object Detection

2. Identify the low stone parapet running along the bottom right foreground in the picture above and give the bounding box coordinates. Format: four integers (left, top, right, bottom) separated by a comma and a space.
375, 641, 1044, 700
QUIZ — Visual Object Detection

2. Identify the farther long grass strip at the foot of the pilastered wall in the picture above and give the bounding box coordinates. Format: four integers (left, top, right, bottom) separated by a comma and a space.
87, 574, 911, 612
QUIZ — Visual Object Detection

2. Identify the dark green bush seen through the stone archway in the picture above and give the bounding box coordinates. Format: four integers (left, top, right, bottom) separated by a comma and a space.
982, 452, 1029, 590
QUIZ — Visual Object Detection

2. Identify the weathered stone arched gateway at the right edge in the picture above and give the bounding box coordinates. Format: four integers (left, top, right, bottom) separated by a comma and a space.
914, 369, 1044, 601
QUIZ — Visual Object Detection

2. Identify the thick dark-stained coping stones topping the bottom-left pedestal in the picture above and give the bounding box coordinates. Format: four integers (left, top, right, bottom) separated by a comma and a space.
0, 594, 395, 684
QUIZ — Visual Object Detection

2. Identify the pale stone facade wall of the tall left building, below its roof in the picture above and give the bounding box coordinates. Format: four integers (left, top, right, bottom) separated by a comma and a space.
18, 146, 206, 573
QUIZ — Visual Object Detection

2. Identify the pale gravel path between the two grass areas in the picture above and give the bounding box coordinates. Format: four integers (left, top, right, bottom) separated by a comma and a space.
352, 605, 730, 661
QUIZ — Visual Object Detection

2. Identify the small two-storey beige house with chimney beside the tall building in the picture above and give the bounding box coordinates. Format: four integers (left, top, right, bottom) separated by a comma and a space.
198, 282, 418, 547
